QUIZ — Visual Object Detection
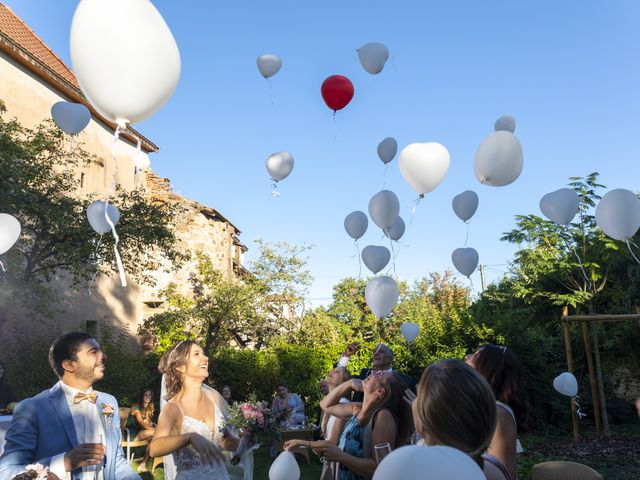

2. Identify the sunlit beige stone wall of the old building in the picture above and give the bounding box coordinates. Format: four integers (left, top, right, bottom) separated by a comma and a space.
0, 47, 244, 348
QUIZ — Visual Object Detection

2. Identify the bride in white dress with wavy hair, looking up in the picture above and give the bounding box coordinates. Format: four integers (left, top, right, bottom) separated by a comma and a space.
149, 340, 239, 480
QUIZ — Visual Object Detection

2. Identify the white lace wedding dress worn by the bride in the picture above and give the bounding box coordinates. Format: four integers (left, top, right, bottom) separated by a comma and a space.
173, 404, 229, 480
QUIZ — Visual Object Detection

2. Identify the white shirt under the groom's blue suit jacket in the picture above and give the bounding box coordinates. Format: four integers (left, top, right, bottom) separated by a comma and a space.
49, 380, 107, 480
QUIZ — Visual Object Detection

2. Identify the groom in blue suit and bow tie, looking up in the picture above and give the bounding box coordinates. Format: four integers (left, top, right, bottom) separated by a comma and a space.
0, 332, 140, 480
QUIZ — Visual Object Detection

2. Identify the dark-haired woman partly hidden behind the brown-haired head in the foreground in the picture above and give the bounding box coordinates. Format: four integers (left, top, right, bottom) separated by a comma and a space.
465, 344, 527, 480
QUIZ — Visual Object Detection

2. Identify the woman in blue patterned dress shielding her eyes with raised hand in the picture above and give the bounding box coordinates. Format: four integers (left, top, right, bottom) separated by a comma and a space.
317, 371, 412, 480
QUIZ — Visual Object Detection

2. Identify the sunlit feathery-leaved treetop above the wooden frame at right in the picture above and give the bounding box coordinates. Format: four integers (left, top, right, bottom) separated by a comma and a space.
501, 172, 637, 311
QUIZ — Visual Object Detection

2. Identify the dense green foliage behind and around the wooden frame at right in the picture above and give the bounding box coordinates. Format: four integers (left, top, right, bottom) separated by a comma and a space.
471, 173, 640, 429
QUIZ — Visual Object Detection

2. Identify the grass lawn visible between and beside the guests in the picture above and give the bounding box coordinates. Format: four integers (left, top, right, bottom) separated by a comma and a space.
134, 426, 640, 480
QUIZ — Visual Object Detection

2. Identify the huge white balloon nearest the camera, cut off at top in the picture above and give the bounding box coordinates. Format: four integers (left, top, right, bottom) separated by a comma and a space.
70, 0, 180, 125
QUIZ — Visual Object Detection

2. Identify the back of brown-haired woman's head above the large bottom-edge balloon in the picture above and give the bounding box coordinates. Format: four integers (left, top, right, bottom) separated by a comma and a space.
414, 359, 497, 466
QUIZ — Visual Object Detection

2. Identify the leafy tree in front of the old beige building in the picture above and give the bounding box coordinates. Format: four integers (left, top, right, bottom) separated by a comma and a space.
0, 103, 183, 285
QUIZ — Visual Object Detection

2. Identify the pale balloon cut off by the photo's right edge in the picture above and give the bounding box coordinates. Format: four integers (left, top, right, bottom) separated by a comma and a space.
596, 188, 640, 242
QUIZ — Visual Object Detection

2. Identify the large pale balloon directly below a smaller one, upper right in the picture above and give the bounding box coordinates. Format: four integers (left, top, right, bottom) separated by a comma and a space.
473, 130, 524, 187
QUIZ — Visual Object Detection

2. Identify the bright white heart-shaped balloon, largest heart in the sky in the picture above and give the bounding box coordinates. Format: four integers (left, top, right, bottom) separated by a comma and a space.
398, 142, 451, 194
